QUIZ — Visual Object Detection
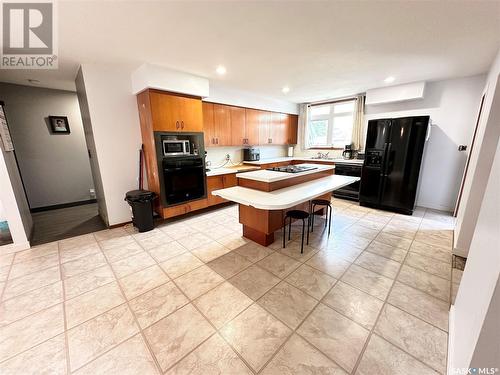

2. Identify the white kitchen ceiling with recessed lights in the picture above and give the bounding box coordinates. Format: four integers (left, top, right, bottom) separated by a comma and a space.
0, 1, 500, 102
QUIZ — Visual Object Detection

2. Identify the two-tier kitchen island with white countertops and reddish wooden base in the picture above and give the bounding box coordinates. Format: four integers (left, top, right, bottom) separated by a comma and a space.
212, 164, 359, 246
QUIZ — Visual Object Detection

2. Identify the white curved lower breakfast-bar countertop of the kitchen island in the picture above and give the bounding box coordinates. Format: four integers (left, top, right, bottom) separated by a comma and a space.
212, 175, 359, 210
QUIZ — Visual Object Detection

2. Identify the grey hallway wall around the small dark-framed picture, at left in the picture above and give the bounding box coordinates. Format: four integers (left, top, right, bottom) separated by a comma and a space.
0, 83, 94, 208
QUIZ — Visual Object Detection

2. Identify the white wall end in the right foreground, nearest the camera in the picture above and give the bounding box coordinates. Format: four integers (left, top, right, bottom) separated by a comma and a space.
449, 142, 500, 374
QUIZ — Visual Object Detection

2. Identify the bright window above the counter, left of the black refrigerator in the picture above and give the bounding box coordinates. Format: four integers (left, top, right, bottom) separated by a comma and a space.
307, 99, 356, 148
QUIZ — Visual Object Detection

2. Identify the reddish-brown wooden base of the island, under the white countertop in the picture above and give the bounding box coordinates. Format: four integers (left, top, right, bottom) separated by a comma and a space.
239, 192, 332, 246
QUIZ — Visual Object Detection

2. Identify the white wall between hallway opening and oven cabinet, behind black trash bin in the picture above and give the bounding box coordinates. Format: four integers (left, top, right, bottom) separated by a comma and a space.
79, 64, 142, 225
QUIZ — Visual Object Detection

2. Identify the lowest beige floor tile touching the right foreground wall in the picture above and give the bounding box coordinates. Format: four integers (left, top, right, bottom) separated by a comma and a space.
375, 305, 448, 373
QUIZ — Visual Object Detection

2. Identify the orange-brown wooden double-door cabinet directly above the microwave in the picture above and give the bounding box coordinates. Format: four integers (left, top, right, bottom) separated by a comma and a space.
148, 90, 203, 132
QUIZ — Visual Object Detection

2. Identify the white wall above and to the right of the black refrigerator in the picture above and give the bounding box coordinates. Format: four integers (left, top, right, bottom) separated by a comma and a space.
364, 75, 485, 211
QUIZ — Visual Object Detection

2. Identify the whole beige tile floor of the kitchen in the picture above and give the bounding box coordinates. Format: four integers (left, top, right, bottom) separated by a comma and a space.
0, 199, 461, 375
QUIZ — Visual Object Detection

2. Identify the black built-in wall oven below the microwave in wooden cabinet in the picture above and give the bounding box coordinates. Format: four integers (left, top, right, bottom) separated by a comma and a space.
162, 156, 206, 206
